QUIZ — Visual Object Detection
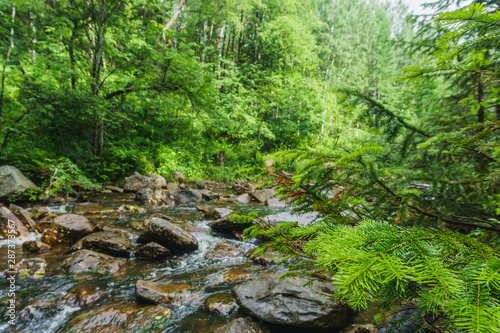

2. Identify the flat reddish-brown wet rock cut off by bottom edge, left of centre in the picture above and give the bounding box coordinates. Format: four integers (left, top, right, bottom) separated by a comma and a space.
63, 303, 171, 333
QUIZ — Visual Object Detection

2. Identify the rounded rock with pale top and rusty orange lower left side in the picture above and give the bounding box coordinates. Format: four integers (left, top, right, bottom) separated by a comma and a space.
42, 214, 93, 246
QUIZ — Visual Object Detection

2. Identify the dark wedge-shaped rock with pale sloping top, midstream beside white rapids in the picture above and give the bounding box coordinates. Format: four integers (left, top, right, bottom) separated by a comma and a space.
137, 217, 198, 251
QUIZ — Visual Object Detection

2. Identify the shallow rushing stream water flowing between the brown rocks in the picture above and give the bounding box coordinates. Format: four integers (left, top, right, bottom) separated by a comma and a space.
0, 194, 374, 333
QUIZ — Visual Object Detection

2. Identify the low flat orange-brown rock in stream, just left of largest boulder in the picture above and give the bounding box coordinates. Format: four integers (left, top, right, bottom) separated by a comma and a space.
135, 280, 203, 306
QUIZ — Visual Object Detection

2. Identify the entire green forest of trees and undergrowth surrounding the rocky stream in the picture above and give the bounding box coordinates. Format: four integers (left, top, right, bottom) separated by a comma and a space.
0, 0, 500, 333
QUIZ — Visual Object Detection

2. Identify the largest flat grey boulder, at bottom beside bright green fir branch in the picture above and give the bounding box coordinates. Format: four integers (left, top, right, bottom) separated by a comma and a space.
232, 276, 353, 329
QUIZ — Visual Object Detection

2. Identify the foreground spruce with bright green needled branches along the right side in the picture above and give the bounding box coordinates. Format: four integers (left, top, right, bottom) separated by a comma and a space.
234, 4, 500, 332
